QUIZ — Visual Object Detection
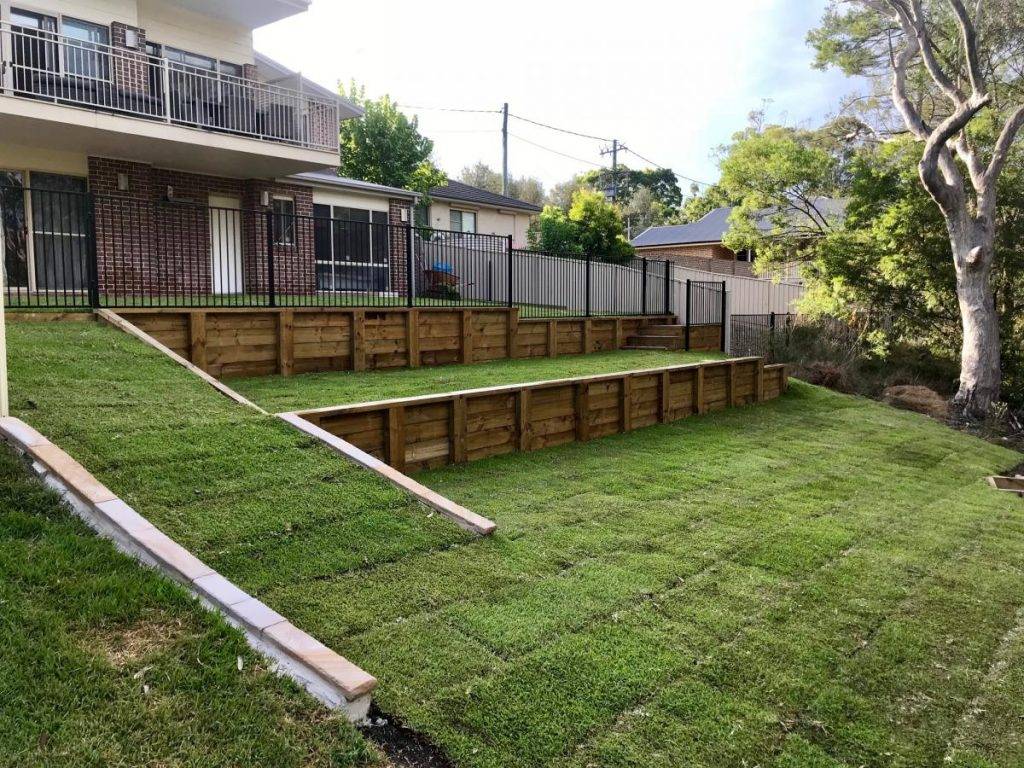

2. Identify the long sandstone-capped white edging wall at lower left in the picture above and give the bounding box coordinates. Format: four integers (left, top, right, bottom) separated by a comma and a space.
0, 417, 377, 722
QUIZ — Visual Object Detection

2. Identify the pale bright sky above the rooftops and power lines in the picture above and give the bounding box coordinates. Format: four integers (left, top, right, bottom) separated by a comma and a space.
256, 0, 851, 195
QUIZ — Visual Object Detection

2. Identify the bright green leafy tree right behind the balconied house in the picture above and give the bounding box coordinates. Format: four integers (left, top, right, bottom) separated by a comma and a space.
339, 83, 445, 193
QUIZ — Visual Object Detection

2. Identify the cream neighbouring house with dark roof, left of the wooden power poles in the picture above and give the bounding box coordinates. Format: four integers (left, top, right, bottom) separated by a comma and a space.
424, 179, 542, 248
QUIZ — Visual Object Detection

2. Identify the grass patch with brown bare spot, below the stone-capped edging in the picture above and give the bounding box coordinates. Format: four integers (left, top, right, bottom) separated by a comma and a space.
0, 447, 377, 768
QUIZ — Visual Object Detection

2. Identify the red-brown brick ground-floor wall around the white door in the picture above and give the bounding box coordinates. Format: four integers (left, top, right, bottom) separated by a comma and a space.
89, 158, 315, 296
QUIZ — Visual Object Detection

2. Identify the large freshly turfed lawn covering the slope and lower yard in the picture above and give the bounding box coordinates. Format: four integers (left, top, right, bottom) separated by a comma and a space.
10, 324, 1024, 768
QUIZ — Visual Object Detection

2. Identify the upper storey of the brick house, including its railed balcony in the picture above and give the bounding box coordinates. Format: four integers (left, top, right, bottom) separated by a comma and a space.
0, 0, 359, 176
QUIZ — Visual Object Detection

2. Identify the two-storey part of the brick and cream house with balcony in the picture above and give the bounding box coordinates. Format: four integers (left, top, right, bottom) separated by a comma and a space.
0, 0, 364, 296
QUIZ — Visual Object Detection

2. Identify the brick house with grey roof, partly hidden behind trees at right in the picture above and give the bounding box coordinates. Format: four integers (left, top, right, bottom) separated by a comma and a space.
632, 198, 846, 280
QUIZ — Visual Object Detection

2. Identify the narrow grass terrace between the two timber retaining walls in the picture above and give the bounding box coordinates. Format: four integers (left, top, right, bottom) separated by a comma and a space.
225, 349, 722, 413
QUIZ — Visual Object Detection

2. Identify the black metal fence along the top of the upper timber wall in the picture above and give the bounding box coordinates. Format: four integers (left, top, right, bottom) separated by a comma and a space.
0, 185, 679, 323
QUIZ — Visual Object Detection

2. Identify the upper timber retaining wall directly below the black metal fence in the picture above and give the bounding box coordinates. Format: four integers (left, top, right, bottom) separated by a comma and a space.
110, 307, 721, 377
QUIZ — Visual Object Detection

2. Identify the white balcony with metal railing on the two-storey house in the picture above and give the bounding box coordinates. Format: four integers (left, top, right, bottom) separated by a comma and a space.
0, 25, 353, 176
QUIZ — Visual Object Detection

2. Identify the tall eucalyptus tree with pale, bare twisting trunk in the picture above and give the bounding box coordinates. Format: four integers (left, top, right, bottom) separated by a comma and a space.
810, 0, 1024, 418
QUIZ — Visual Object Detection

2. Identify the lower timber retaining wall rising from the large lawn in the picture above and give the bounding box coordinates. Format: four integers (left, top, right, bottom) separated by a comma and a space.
296, 358, 787, 472
